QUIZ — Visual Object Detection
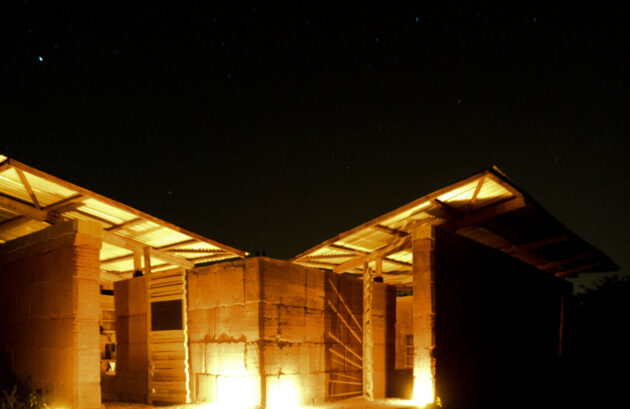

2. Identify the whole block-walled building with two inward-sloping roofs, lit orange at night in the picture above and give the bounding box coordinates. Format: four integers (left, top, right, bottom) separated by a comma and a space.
0, 156, 617, 408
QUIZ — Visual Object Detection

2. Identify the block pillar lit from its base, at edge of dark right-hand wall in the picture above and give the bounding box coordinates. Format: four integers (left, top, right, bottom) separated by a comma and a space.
411, 224, 435, 405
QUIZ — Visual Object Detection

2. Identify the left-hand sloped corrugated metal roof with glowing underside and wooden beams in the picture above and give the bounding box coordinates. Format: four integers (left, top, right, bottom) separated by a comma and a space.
0, 155, 247, 274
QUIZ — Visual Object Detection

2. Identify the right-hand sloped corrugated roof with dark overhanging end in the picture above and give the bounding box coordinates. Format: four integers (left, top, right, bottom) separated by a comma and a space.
291, 167, 618, 285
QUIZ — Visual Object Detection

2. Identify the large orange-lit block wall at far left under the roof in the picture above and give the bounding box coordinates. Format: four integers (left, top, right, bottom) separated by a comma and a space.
0, 221, 101, 409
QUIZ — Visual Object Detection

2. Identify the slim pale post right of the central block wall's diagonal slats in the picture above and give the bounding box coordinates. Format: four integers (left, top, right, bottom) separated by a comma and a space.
363, 263, 374, 400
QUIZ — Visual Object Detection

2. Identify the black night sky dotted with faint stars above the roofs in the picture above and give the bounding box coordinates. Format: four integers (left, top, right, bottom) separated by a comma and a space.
0, 1, 630, 284
